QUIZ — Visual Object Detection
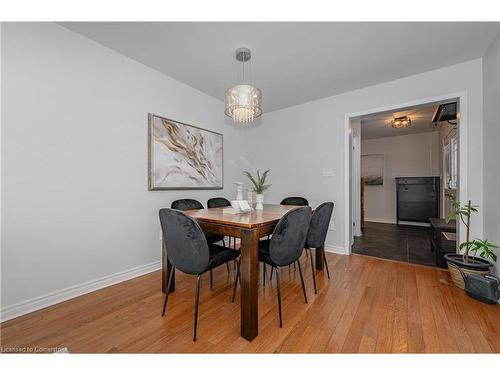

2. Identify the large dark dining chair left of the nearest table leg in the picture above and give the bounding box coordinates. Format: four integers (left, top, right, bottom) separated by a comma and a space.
160, 208, 240, 341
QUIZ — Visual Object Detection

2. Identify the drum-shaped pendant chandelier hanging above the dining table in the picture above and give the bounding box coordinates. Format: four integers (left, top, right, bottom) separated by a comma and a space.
224, 48, 262, 123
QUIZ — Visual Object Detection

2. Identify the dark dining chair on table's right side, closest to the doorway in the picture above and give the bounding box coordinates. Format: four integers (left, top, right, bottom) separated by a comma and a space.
305, 202, 333, 294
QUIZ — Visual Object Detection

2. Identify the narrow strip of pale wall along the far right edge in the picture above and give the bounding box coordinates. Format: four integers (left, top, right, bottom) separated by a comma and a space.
482, 30, 500, 276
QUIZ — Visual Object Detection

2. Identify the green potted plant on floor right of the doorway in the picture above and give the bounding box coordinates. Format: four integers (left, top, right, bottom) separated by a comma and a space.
444, 196, 498, 289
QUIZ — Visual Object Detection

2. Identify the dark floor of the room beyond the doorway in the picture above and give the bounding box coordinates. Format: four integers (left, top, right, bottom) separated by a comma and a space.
352, 221, 436, 266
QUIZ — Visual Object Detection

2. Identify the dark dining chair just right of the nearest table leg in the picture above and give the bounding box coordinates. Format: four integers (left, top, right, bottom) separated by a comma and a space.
259, 207, 311, 327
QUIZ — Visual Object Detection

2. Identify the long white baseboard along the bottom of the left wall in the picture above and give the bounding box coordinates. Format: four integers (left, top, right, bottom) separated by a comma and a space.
0, 261, 161, 322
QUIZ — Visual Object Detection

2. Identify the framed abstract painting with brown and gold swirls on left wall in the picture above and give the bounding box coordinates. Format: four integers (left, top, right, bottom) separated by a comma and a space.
148, 113, 224, 190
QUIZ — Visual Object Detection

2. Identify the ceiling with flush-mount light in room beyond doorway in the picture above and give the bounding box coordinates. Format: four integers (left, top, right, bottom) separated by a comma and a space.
361, 103, 439, 139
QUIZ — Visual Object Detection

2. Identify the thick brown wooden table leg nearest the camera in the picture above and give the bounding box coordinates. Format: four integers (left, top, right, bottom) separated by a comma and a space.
240, 229, 259, 341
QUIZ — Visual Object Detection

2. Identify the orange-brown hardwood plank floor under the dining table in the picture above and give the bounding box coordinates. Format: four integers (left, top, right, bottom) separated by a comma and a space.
1, 254, 500, 353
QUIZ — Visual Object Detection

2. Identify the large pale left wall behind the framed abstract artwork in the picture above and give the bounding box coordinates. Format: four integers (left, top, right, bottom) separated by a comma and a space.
1, 23, 249, 318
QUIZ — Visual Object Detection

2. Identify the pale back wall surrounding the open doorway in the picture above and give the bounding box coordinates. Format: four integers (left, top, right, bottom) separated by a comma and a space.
254, 59, 483, 253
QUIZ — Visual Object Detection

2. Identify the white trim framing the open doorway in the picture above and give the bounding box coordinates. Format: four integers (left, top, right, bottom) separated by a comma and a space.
344, 91, 468, 254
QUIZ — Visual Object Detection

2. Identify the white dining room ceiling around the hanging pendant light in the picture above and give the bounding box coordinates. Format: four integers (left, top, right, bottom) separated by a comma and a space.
61, 22, 499, 112
